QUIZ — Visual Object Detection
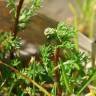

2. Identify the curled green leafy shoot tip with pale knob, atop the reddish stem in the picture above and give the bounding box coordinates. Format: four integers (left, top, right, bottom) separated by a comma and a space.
44, 23, 75, 49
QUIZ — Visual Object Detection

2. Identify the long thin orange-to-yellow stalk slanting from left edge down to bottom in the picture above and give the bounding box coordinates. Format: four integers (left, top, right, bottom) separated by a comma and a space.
0, 61, 51, 96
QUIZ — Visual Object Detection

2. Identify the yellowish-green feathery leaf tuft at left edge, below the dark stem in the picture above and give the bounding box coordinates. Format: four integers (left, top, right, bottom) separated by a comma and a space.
0, 32, 21, 51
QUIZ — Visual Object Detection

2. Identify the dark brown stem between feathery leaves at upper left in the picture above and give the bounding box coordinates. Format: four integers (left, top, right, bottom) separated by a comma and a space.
13, 0, 24, 38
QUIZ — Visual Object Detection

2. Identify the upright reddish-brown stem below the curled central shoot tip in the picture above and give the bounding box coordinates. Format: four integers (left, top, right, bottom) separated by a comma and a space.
54, 48, 62, 96
